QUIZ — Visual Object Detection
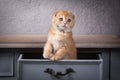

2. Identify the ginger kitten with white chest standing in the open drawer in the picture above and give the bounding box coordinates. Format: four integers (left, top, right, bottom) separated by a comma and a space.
43, 10, 77, 61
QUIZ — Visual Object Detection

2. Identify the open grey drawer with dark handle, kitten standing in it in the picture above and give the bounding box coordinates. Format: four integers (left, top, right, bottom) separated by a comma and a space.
18, 54, 103, 80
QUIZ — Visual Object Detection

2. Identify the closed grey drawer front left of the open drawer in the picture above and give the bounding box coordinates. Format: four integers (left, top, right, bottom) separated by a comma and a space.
0, 53, 13, 76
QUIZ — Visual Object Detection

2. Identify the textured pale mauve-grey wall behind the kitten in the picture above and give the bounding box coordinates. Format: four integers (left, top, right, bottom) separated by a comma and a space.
0, 0, 120, 35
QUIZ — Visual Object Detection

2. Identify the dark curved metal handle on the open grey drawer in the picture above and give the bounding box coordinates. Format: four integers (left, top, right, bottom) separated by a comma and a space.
44, 68, 75, 78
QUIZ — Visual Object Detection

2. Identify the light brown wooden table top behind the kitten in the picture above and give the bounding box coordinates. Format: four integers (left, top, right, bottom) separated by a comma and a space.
0, 34, 120, 48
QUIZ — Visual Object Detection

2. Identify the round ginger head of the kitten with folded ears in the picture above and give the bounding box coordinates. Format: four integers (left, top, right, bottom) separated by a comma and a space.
52, 10, 75, 32
